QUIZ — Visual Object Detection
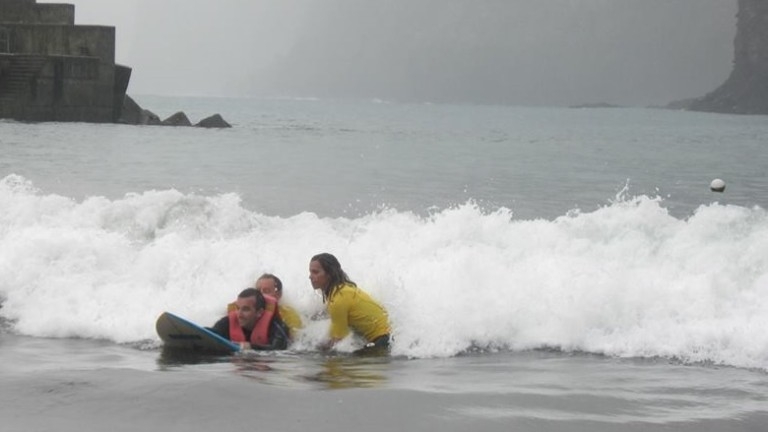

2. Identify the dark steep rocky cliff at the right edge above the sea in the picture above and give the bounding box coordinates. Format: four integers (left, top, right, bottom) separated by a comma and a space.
689, 0, 768, 114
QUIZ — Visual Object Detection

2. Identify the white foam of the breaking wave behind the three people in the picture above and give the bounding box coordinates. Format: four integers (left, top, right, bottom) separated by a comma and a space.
0, 175, 768, 369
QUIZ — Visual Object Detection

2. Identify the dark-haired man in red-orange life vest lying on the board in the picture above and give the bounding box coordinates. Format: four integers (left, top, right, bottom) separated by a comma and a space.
209, 288, 290, 350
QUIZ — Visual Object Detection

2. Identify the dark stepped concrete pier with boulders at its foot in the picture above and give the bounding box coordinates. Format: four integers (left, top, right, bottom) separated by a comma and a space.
0, 0, 230, 127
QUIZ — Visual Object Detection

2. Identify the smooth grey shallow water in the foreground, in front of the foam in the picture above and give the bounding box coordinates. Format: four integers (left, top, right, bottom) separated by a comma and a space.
0, 335, 768, 431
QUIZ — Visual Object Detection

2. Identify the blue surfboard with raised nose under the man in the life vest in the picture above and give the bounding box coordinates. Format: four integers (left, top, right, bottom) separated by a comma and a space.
155, 312, 240, 353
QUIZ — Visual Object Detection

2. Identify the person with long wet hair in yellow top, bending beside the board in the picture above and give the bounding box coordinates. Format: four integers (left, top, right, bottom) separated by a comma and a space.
309, 253, 391, 353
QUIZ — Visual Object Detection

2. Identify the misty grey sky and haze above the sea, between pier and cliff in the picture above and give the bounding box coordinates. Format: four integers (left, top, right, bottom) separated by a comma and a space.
64, 0, 737, 106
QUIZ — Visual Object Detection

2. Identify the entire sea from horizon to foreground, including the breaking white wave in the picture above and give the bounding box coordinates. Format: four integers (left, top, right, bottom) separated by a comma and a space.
0, 96, 768, 432
